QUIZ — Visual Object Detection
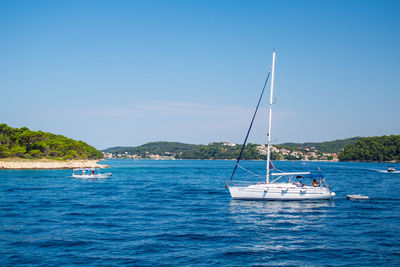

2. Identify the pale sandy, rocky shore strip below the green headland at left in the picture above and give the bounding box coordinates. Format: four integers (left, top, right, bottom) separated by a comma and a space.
0, 158, 110, 170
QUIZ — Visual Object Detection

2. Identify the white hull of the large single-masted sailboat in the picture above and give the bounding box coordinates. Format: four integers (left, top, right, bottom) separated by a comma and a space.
229, 183, 334, 200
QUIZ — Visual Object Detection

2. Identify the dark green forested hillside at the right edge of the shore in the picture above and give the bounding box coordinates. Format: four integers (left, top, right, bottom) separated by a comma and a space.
339, 135, 400, 161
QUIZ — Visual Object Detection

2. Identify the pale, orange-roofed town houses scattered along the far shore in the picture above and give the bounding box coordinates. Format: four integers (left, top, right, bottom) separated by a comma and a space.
103, 142, 339, 161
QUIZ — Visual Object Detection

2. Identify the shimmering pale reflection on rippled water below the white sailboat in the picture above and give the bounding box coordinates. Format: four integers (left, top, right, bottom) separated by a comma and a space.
228, 200, 335, 258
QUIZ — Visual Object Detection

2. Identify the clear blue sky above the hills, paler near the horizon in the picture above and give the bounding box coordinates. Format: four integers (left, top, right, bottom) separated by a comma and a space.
0, 0, 400, 149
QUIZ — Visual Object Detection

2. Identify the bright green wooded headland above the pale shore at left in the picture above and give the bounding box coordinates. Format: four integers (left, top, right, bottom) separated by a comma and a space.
0, 123, 103, 159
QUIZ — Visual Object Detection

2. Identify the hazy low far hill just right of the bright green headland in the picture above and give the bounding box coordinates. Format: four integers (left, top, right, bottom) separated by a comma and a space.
103, 141, 201, 156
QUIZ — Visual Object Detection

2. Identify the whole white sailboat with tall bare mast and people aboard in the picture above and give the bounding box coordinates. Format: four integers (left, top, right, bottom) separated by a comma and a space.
226, 51, 335, 200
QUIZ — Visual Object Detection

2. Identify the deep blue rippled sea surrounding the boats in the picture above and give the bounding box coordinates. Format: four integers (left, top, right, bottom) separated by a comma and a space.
0, 160, 400, 266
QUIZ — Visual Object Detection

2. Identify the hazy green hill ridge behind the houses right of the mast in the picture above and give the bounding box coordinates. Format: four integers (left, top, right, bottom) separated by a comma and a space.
282, 136, 363, 153
